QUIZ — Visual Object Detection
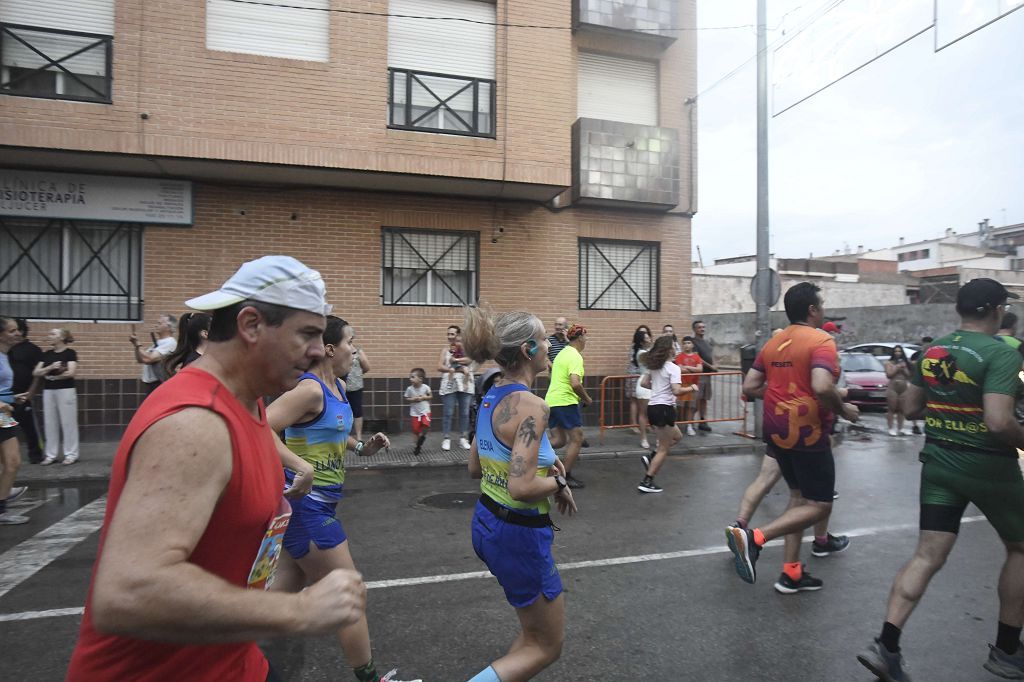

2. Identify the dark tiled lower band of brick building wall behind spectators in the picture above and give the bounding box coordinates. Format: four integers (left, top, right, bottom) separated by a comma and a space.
35, 376, 622, 442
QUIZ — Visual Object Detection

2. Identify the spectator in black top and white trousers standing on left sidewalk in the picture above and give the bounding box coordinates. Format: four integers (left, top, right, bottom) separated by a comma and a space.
32, 329, 78, 466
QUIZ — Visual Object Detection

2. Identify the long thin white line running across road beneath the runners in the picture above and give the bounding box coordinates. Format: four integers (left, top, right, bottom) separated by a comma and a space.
0, 512, 985, 623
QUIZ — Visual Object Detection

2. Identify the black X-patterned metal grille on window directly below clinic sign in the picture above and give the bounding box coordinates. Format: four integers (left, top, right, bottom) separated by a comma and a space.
0, 215, 145, 322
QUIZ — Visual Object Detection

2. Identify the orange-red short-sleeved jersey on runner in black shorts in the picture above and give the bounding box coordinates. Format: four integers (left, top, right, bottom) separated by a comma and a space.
754, 325, 839, 452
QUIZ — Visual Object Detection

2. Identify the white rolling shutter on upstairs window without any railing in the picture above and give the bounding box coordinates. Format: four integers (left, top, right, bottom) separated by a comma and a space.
206, 0, 331, 61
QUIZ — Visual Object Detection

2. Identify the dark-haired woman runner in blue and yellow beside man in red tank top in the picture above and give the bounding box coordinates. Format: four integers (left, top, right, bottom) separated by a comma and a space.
266, 315, 421, 682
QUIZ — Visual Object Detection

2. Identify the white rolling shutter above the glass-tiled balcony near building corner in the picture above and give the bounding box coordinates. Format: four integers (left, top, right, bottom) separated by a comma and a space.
577, 52, 657, 126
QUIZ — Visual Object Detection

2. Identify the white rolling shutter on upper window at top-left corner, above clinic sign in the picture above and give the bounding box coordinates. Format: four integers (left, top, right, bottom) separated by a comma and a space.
0, 0, 114, 76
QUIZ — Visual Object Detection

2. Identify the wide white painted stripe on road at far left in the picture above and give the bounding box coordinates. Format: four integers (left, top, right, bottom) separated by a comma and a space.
0, 495, 106, 598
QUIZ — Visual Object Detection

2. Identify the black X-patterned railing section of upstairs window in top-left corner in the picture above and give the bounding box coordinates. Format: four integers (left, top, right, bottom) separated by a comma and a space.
0, 24, 114, 103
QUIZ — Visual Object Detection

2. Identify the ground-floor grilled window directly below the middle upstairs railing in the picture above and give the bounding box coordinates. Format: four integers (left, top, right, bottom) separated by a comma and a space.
381, 227, 480, 306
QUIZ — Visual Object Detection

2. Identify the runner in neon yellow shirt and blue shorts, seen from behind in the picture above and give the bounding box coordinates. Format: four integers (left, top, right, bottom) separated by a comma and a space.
544, 325, 592, 489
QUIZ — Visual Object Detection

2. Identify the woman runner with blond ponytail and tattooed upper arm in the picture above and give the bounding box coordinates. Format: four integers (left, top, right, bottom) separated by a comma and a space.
462, 308, 575, 682
